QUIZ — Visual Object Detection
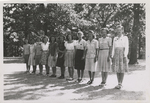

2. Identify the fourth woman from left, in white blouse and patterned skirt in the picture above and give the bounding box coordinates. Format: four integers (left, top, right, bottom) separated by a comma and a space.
40, 37, 49, 76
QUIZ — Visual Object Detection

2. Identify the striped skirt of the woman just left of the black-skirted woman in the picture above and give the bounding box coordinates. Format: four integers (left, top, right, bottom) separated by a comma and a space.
64, 50, 74, 67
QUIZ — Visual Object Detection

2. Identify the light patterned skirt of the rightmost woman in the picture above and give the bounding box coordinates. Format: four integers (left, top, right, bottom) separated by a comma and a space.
112, 47, 128, 73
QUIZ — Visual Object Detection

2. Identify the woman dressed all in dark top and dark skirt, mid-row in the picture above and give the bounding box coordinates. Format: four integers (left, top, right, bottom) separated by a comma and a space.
56, 36, 65, 79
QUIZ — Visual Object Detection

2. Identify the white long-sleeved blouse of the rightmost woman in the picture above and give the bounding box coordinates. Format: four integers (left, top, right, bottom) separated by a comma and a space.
112, 35, 129, 57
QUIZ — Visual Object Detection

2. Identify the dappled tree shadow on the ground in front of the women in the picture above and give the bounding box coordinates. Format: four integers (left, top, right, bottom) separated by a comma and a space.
4, 68, 145, 100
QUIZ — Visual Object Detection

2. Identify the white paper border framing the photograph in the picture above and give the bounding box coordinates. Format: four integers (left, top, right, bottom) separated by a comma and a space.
0, 0, 150, 103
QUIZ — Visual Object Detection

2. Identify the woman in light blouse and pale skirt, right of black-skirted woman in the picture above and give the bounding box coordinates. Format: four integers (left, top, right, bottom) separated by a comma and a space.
84, 30, 98, 84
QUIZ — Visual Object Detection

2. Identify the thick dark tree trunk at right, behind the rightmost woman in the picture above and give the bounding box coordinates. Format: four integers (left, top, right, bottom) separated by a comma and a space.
129, 4, 140, 64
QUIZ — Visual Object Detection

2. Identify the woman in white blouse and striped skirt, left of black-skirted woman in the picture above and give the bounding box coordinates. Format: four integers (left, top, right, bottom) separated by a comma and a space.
64, 34, 75, 81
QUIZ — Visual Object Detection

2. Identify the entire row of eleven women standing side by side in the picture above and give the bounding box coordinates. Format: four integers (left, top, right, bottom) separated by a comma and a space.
24, 25, 129, 89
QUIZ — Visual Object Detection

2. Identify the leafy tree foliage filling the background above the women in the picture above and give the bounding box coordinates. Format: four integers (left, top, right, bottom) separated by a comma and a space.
3, 3, 145, 63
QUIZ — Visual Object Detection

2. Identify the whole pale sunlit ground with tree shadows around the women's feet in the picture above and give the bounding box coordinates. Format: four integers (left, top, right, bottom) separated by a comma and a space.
3, 60, 147, 102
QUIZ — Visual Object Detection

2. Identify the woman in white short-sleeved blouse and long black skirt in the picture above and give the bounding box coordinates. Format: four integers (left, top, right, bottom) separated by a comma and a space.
75, 31, 86, 82
